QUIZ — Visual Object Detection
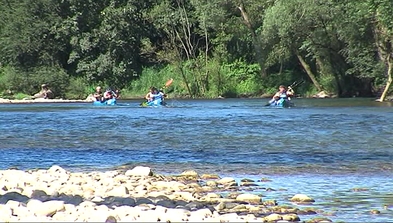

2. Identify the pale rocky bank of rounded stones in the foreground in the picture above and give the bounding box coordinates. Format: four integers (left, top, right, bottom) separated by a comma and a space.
0, 166, 331, 223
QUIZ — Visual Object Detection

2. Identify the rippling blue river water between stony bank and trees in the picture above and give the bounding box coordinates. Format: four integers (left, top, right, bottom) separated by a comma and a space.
0, 99, 393, 222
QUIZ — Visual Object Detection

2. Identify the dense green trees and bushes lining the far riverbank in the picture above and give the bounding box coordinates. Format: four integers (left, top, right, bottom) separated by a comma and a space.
0, 0, 393, 98
